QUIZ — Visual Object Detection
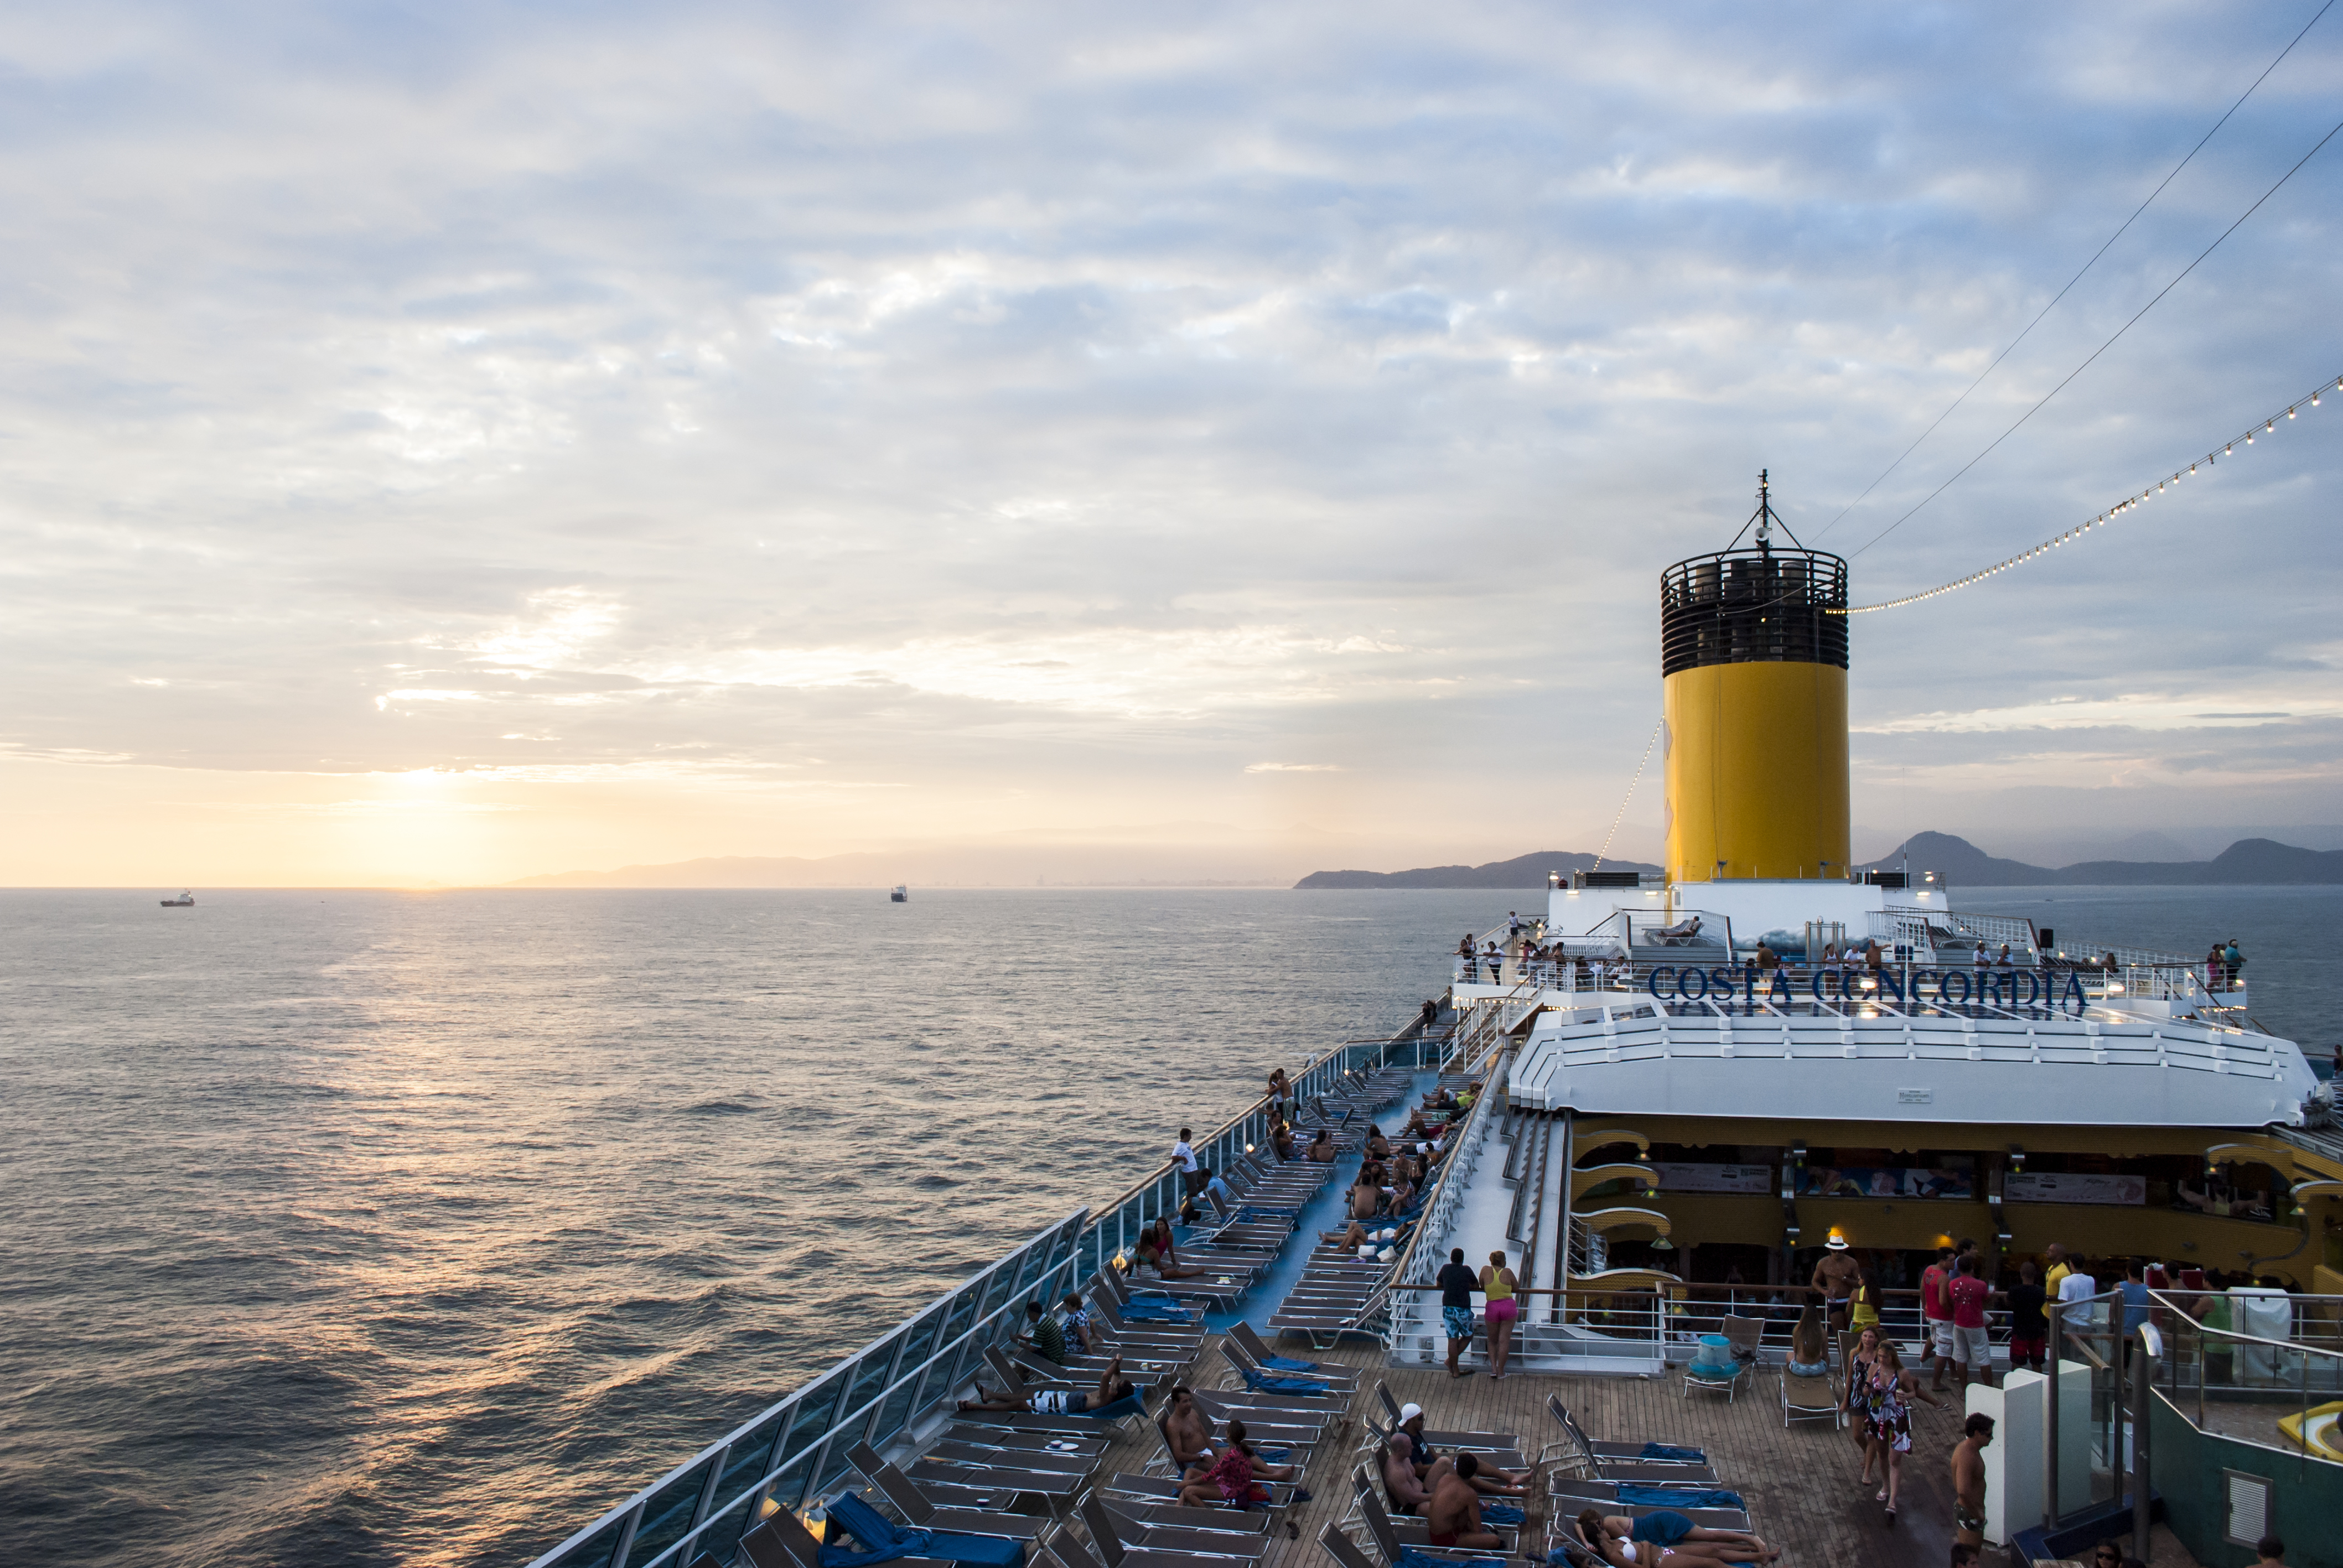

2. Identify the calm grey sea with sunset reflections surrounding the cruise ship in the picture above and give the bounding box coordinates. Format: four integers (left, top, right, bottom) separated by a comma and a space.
0, 889, 2343, 1566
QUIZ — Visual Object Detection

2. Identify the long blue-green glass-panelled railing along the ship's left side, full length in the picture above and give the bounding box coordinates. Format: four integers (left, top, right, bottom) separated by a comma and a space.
530, 1008, 1445, 1568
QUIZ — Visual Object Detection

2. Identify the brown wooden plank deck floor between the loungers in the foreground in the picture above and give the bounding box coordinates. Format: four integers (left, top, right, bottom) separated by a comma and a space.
1064, 1343, 2191, 1568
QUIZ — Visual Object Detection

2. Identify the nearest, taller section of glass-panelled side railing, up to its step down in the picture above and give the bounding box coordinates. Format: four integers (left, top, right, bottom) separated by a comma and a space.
532, 1209, 1085, 1568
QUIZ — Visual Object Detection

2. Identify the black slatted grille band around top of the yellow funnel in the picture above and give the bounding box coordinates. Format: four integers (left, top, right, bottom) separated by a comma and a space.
1659, 548, 1846, 675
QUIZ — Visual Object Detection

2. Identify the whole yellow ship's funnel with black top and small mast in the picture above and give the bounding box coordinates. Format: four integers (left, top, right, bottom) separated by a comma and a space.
1659, 476, 1849, 881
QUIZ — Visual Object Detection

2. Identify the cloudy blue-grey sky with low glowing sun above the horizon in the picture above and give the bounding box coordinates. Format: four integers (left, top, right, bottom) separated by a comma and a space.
0, 0, 2343, 886
